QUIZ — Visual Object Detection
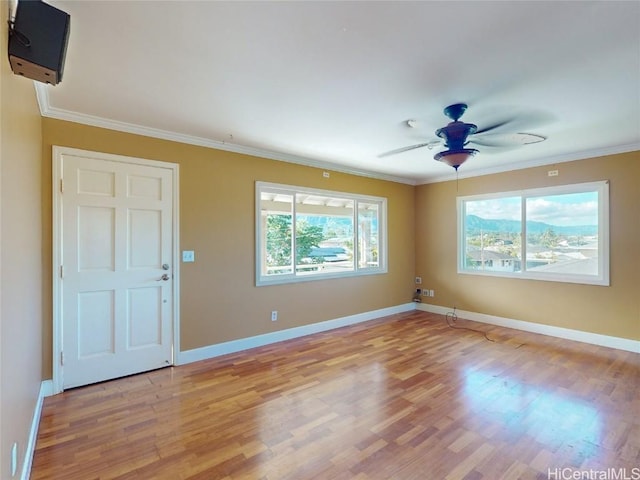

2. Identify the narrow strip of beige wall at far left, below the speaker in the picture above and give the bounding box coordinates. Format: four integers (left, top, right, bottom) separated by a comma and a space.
0, 1, 43, 479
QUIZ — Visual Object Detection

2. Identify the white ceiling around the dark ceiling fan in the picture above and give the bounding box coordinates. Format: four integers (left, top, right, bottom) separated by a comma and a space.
36, 0, 640, 184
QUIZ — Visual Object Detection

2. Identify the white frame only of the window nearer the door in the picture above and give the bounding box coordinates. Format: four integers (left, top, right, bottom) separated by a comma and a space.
254, 181, 388, 287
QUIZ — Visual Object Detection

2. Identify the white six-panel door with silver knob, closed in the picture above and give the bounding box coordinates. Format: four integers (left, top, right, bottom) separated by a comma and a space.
57, 152, 175, 388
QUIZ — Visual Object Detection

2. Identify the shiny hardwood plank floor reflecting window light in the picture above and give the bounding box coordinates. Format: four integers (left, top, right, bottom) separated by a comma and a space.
31, 311, 640, 480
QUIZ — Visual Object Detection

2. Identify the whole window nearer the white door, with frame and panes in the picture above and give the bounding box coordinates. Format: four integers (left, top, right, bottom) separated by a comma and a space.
256, 182, 387, 285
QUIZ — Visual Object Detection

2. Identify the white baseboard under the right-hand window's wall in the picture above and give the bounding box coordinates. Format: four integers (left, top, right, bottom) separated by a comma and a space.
416, 303, 640, 353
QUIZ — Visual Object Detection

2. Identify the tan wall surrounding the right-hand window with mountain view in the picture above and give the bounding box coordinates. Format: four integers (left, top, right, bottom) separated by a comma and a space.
416, 152, 640, 340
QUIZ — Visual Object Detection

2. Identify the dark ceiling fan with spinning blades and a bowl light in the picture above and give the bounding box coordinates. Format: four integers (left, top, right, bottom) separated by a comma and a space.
379, 103, 546, 170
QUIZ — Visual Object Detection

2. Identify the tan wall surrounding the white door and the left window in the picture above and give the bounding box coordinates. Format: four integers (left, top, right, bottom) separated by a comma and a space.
42, 119, 415, 378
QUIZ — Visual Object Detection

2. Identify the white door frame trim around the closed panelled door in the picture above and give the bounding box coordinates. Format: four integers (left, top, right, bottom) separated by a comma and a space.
52, 145, 180, 394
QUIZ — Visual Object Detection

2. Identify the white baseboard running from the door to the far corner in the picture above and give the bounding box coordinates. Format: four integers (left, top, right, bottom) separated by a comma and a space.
176, 303, 415, 365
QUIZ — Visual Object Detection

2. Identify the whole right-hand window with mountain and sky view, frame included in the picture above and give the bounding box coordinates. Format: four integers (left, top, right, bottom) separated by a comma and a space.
458, 181, 609, 285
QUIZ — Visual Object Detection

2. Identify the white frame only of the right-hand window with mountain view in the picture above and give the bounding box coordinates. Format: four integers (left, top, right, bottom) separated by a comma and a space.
456, 180, 610, 286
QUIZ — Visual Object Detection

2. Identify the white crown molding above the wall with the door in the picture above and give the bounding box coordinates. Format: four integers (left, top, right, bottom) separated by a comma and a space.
34, 82, 416, 185
